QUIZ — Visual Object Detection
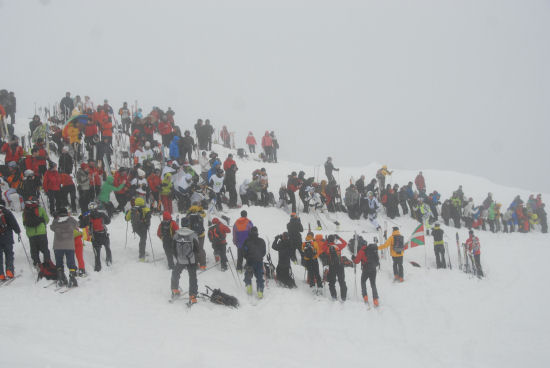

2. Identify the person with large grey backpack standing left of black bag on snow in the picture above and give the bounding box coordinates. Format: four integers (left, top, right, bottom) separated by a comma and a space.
170, 218, 199, 305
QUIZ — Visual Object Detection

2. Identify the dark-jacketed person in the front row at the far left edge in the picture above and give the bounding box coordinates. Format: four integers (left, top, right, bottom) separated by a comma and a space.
0, 198, 21, 281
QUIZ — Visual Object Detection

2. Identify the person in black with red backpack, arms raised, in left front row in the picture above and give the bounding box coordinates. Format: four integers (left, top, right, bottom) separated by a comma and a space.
79, 202, 113, 272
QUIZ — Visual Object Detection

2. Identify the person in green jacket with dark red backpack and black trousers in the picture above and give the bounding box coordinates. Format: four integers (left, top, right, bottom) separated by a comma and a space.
23, 197, 51, 267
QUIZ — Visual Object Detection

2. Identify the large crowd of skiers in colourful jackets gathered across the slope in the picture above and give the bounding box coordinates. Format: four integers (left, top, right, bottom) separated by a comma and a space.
0, 91, 547, 306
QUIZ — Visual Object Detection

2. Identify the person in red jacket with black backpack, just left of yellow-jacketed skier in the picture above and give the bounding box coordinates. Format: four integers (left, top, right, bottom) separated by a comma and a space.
351, 236, 380, 307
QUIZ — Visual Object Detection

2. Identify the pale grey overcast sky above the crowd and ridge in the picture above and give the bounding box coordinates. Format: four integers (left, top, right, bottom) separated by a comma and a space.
0, 0, 550, 192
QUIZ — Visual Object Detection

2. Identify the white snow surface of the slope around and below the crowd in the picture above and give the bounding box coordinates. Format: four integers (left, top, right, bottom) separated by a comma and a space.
0, 146, 550, 368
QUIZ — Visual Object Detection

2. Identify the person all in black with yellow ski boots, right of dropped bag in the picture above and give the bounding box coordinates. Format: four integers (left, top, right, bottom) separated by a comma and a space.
242, 226, 266, 299
